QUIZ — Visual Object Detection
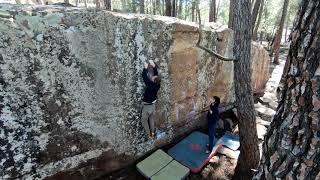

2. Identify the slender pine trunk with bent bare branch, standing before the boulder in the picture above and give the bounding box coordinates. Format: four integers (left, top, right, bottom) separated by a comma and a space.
233, 0, 260, 180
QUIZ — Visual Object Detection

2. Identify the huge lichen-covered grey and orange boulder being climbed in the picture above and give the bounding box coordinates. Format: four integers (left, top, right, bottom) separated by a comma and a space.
0, 4, 269, 179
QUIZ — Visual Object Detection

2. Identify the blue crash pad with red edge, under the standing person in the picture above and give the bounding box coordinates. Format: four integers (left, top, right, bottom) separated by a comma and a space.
168, 131, 222, 173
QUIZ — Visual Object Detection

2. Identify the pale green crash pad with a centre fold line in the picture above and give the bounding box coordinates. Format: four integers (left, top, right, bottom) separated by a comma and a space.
136, 149, 189, 180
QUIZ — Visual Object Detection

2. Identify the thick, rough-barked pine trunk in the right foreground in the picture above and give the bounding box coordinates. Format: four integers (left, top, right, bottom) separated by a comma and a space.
255, 0, 320, 180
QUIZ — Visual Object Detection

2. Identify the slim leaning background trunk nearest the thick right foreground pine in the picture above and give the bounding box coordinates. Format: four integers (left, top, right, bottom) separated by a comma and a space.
273, 0, 289, 64
